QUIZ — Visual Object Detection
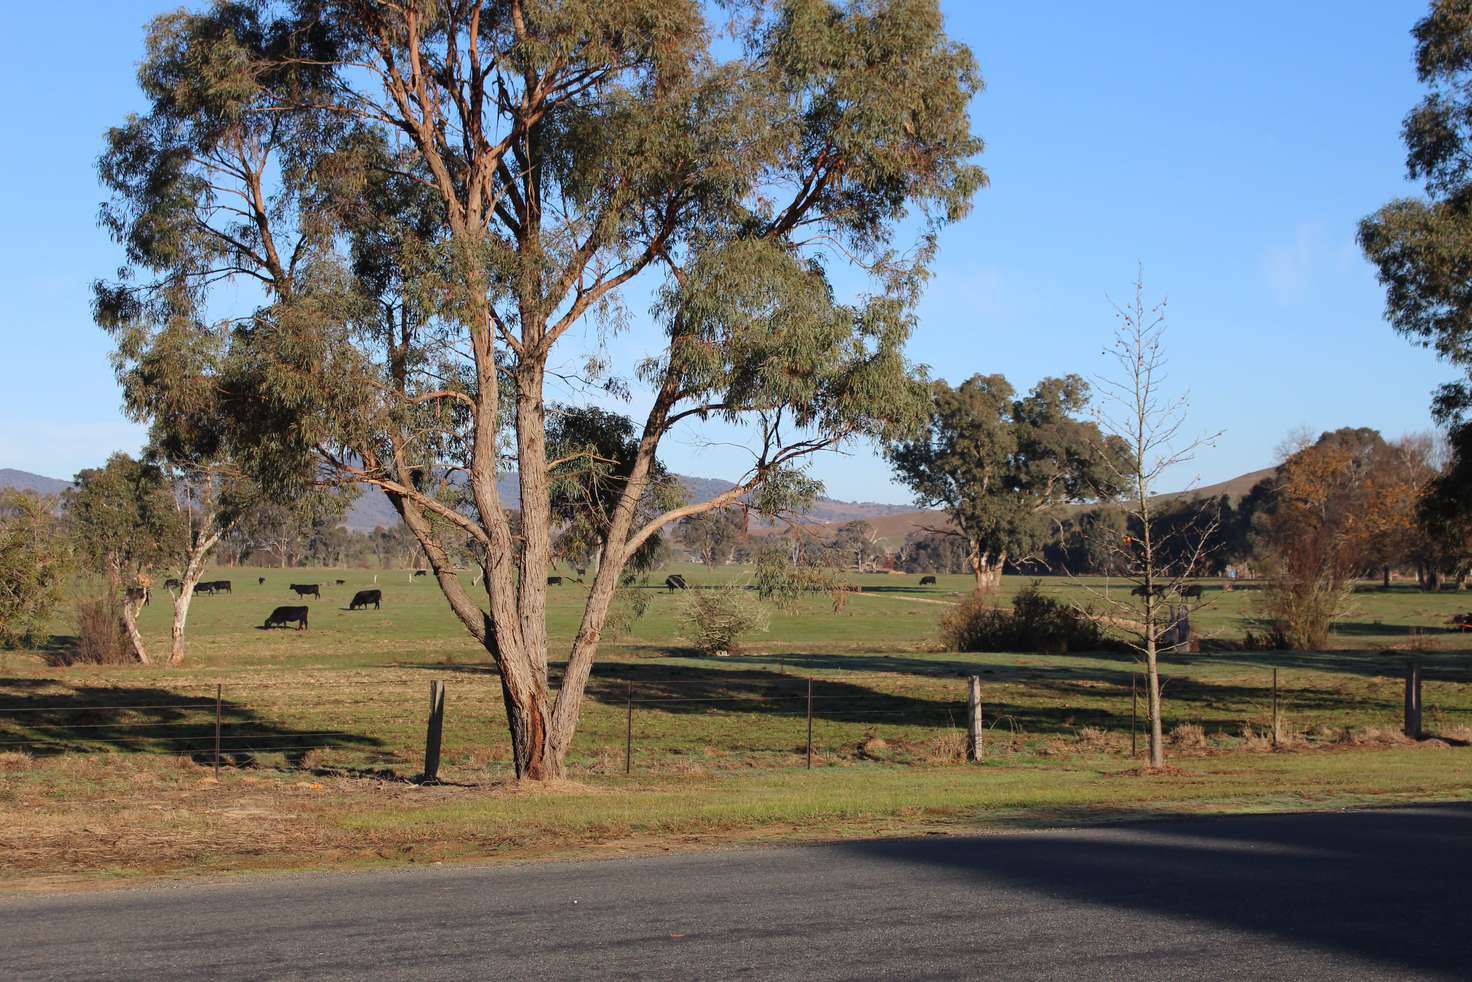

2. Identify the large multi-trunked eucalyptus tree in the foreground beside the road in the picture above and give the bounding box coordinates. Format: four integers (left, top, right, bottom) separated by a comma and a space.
97, 0, 985, 779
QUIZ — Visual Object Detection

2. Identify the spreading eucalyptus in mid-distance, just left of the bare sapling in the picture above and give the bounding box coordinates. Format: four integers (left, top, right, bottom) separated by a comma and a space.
888, 375, 1123, 590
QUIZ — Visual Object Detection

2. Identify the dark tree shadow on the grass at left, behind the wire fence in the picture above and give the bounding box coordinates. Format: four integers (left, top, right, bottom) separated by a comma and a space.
0, 679, 383, 767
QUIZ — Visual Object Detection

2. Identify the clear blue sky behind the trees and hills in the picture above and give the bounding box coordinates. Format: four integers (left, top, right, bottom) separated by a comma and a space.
0, 0, 1450, 504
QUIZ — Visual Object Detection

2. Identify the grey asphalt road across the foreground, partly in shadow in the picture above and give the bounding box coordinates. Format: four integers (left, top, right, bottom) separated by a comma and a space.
0, 805, 1472, 982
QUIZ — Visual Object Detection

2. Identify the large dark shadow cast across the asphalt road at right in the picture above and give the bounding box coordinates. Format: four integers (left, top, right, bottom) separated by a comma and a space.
832, 804, 1472, 978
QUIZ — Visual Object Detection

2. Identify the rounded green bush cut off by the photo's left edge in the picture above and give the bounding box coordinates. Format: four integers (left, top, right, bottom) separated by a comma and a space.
0, 489, 72, 646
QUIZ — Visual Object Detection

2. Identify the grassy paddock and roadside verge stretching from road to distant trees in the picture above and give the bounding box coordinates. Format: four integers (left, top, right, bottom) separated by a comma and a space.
0, 568, 1472, 882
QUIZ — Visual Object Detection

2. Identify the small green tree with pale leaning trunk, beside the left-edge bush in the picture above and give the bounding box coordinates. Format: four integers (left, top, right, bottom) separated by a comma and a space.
62, 453, 183, 665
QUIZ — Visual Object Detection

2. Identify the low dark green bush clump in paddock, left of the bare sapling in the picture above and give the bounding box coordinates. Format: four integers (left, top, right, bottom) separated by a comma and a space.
941, 583, 1111, 655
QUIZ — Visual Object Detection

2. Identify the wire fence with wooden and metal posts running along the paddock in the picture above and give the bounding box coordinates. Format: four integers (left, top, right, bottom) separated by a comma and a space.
0, 663, 1472, 779
